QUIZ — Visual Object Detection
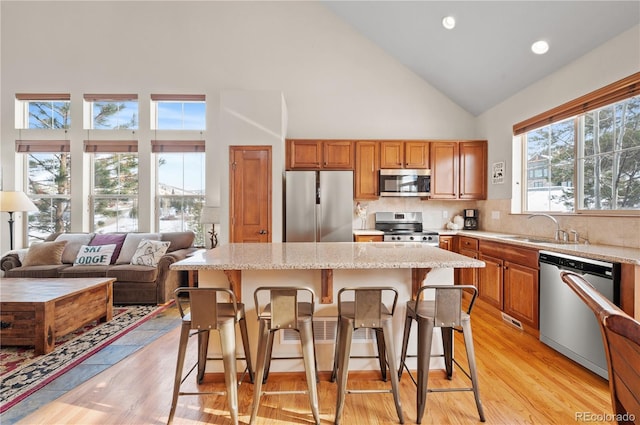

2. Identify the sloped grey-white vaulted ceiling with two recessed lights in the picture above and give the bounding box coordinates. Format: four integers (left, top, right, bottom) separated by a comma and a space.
324, 0, 640, 115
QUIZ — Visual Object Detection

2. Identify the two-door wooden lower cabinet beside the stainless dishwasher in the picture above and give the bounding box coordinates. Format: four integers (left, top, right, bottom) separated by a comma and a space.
478, 240, 539, 330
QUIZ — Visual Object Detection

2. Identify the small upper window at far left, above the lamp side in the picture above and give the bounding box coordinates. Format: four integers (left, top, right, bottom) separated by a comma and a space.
16, 93, 71, 129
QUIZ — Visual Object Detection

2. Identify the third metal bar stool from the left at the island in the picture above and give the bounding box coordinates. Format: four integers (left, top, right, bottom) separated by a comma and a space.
335, 287, 404, 425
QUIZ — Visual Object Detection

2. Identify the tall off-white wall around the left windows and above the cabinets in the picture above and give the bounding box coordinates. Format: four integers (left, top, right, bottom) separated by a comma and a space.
0, 1, 475, 251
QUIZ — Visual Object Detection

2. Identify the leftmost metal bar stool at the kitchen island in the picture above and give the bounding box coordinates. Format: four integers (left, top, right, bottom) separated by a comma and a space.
167, 288, 253, 424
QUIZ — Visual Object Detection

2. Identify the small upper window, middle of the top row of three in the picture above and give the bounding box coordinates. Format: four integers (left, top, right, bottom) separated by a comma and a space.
84, 94, 138, 130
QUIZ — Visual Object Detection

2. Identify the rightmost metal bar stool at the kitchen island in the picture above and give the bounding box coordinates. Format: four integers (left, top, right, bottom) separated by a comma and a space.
398, 285, 485, 424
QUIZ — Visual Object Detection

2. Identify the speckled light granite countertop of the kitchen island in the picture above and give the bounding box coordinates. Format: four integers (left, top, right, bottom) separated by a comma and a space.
171, 242, 485, 270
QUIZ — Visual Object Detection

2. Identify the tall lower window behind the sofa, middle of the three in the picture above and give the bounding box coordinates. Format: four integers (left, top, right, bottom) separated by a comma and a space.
85, 140, 138, 233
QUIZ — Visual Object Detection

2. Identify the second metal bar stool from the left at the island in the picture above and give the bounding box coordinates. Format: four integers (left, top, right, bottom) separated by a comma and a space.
249, 286, 320, 424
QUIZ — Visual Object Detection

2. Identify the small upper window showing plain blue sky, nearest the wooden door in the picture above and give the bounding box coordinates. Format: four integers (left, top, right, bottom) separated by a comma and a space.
151, 94, 206, 130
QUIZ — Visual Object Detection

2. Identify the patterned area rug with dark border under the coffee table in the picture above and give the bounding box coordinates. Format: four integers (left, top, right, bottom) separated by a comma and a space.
0, 304, 171, 413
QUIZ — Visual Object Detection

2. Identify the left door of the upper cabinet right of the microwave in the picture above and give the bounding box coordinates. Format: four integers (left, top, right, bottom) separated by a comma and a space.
430, 142, 458, 199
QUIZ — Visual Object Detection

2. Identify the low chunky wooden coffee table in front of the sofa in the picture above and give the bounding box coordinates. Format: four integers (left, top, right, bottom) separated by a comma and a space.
0, 278, 115, 354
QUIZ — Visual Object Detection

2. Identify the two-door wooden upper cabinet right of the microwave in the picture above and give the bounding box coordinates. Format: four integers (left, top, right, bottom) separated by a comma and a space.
431, 140, 487, 199
